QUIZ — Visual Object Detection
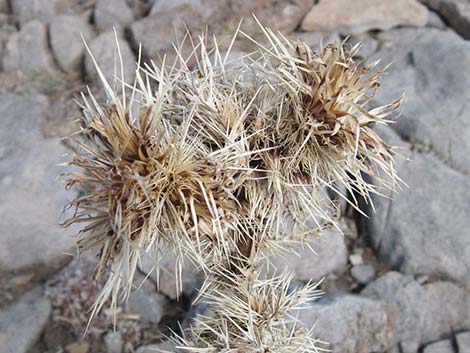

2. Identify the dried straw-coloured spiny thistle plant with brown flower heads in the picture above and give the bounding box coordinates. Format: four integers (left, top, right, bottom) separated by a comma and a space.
61, 20, 400, 353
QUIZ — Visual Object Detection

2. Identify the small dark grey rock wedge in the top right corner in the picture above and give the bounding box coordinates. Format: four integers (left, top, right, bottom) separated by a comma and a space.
420, 0, 470, 39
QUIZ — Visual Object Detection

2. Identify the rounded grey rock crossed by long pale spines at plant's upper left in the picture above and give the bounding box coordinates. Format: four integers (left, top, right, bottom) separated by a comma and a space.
85, 31, 136, 88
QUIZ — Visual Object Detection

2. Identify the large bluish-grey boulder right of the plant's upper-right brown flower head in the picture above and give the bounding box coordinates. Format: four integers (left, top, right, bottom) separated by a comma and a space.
372, 28, 470, 175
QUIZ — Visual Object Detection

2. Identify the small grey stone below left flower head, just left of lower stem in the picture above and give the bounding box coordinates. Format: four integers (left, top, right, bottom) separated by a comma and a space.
126, 290, 167, 324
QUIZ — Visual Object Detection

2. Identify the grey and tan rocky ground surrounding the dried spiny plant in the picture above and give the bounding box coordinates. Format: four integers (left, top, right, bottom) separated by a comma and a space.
0, 0, 470, 353
